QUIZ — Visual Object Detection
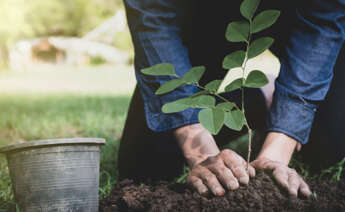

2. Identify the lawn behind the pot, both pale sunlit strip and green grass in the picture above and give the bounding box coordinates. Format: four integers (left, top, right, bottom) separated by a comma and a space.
0, 66, 135, 212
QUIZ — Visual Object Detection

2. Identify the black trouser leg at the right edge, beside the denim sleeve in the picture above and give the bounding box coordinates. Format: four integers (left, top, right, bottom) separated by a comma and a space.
301, 46, 345, 168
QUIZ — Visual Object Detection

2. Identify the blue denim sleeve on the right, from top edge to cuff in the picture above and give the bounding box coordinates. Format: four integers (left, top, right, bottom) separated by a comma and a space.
268, 0, 345, 144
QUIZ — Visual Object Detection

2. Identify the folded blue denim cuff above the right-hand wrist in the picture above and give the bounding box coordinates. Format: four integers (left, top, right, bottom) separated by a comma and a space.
267, 83, 317, 144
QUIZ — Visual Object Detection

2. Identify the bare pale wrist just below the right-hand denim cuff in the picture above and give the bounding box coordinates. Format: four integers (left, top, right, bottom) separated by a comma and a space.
257, 132, 300, 165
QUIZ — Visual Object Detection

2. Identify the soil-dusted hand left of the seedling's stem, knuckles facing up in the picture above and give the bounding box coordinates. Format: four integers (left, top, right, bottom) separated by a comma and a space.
187, 149, 255, 196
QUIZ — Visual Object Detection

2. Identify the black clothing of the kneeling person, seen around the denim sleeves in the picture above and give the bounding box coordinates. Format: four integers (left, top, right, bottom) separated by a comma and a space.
118, 0, 345, 181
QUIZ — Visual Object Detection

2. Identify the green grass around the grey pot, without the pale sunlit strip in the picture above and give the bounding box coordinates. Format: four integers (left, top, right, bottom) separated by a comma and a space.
0, 94, 130, 211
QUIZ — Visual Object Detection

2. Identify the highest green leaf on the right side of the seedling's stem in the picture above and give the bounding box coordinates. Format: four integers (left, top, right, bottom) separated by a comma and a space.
251, 10, 280, 33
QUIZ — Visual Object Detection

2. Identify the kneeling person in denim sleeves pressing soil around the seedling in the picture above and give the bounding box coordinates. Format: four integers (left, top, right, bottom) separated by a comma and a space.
118, 0, 345, 196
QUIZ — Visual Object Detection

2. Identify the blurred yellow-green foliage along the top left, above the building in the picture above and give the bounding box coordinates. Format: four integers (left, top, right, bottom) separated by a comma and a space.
0, 0, 123, 67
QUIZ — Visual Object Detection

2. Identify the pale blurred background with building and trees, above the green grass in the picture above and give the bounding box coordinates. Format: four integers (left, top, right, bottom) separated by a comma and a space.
0, 0, 133, 94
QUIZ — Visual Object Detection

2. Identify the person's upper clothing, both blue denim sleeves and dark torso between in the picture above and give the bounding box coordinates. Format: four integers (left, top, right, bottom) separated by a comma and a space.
124, 0, 345, 144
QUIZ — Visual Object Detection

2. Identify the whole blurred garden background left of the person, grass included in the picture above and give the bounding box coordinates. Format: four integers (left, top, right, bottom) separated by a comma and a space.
0, 0, 136, 211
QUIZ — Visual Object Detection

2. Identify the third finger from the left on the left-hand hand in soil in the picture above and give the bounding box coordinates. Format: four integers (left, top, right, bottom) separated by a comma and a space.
210, 163, 239, 190
